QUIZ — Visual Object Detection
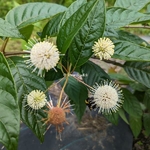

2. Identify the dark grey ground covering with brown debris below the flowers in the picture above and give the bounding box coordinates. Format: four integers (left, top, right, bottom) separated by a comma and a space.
0, 112, 133, 150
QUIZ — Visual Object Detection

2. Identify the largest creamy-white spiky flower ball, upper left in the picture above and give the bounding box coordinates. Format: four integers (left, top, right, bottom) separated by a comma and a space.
26, 39, 60, 75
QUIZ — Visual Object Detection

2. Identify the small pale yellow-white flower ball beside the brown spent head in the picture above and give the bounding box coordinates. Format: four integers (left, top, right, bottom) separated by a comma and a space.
27, 90, 47, 110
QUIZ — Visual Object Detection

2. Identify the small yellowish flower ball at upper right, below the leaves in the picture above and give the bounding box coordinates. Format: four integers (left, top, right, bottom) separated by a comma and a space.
92, 37, 115, 60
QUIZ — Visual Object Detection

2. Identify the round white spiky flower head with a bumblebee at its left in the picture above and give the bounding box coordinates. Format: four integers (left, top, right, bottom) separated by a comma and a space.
93, 81, 123, 114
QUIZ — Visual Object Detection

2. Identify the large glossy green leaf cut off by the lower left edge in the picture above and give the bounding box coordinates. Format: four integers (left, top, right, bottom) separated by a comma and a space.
0, 53, 20, 150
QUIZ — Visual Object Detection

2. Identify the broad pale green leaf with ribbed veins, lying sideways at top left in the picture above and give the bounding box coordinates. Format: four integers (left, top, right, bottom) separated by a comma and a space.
5, 2, 66, 29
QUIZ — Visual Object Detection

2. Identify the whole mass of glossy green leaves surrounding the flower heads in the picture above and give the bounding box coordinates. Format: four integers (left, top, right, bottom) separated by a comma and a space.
0, 0, 150, 150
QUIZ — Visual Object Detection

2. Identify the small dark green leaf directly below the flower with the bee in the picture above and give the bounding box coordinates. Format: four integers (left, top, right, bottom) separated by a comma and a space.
104, 113, 119, 125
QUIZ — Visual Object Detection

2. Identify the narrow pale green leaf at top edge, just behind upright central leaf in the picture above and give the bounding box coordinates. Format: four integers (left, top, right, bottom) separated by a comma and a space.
60, 0, 87, 28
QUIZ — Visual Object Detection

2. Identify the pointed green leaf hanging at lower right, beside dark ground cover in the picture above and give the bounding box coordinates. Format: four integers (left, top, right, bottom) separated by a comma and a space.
129, 116, 142, 138
